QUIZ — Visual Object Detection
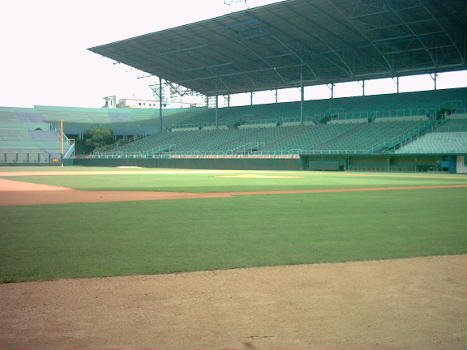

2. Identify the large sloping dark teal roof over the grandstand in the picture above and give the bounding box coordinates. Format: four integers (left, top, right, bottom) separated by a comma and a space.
90, 0, 467, 95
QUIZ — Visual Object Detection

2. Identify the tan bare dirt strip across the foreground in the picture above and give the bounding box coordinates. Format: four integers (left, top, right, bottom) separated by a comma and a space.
0, 255, 467, 350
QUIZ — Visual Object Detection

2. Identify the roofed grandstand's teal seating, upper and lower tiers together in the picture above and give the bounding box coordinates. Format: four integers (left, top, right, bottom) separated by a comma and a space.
95, 88, 467, 154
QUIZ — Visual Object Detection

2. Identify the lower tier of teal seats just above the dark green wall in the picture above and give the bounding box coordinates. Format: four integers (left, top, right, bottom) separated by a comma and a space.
95, 121, 436, 154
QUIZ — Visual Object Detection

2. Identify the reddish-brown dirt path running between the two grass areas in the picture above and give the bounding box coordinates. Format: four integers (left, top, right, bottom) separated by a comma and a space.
0, 178, 467, 205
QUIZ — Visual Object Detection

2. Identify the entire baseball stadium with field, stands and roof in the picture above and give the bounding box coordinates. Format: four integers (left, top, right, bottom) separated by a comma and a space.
0, 0, 467, 350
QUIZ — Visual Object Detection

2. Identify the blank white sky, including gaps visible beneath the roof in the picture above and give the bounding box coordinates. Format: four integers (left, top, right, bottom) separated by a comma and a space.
0, 0, 467, 107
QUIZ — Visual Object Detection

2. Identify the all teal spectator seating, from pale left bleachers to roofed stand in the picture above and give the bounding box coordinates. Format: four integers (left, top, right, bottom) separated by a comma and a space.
0, 88, 467, 162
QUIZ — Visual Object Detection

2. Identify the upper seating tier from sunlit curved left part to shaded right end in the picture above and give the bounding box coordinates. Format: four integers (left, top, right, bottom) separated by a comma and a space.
24, 88, 467, 135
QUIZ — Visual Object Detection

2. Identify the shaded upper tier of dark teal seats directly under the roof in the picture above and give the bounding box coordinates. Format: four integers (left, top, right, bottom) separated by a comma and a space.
172, 88, 467, 129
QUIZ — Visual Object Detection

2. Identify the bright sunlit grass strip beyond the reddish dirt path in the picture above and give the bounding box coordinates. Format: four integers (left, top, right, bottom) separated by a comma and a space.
1, 167, 466, 192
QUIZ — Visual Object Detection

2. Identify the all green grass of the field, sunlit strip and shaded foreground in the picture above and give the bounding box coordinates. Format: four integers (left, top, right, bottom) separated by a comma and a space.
0, 167, 466, 282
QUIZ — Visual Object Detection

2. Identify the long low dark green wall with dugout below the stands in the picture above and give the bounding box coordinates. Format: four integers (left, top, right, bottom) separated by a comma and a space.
60, 155, 465, 173
